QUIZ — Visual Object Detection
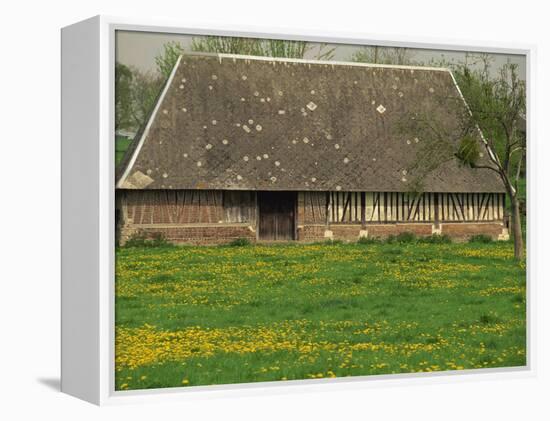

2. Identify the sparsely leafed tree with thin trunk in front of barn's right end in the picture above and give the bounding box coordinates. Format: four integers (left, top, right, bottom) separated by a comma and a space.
404, 63, 526, 259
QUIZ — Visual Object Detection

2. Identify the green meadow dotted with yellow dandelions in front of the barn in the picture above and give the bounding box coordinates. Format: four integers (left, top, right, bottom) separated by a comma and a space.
116, 242, 526, 390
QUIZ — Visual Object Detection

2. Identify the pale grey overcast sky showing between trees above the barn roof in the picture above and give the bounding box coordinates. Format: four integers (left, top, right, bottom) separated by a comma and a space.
116, 31, 526, 80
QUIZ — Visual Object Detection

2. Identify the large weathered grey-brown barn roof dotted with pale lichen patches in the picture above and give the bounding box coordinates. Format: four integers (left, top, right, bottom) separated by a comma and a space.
117, 54, 503, 192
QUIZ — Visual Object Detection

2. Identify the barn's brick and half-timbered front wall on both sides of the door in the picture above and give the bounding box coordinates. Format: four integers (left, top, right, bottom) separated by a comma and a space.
117, 190, 508, 244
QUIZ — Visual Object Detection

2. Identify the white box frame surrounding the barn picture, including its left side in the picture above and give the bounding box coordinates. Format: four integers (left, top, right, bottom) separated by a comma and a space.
61, 16, 535, 405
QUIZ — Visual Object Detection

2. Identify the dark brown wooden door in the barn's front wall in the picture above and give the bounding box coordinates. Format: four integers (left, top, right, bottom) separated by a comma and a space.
258, 192, 296, 240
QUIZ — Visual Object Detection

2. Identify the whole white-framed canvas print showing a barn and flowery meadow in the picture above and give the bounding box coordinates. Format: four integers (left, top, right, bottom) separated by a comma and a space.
62, 17, 531, 403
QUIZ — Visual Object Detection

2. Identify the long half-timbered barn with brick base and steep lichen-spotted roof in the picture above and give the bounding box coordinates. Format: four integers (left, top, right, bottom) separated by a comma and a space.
116, 54, 508, 244
